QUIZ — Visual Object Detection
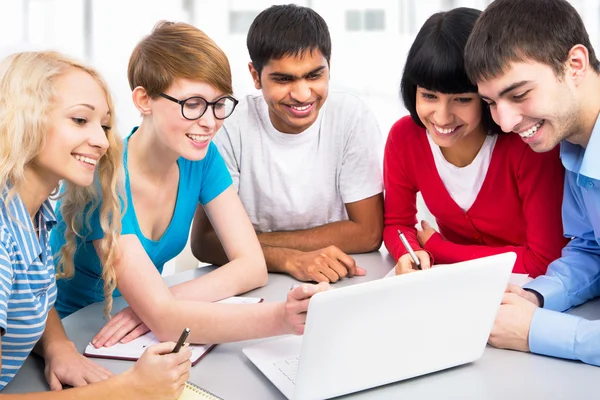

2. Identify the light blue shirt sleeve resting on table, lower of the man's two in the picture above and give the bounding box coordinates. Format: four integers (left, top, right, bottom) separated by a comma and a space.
529, 308, 600, 366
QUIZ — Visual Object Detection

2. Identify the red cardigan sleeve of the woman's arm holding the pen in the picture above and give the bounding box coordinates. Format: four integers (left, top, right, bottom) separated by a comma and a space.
383, 118, 421, 261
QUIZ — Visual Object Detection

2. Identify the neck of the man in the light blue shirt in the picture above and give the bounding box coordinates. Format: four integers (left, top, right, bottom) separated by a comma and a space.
567, 72, 600, 148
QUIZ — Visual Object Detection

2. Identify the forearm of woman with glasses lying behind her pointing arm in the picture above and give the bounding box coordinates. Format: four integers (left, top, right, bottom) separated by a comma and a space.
170, 253, 268, 302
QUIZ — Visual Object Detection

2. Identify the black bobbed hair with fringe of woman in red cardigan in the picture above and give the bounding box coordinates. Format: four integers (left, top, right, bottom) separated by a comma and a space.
400, 7, 502, 133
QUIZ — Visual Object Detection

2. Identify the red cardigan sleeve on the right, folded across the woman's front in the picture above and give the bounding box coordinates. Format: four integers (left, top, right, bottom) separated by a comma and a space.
425, 147, 568, 278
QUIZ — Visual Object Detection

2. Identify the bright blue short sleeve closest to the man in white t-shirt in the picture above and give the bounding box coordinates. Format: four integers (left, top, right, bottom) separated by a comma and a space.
198, 143, 232, 205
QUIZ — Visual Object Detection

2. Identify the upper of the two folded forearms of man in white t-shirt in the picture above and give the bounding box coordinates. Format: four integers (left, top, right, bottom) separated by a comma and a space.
258, 221, 381, 253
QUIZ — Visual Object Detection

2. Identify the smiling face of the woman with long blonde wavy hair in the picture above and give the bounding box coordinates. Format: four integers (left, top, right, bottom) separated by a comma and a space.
30, 68, 110, 186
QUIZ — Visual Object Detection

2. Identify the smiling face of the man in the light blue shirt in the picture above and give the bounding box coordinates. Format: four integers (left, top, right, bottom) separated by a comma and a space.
478, 61, 581, 152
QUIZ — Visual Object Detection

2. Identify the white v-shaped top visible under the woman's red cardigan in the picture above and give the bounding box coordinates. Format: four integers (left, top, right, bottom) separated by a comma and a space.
427, 132, 498, 212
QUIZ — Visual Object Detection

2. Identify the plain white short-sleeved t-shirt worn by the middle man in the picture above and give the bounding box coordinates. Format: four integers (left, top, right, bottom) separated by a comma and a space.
214, 92, 383, 232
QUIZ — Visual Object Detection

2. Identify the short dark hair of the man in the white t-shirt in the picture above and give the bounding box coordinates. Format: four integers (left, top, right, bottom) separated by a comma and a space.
246, 4, 331, 78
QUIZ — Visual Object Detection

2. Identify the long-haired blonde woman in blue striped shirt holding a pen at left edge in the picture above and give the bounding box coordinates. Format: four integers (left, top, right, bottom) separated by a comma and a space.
0, 52, 190, 399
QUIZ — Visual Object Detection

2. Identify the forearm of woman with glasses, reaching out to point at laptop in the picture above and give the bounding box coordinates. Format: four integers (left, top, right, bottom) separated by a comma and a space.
144, 301, 291, 343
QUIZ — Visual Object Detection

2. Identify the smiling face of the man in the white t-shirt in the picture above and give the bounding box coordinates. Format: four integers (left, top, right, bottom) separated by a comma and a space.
249, 50, 329, 133
